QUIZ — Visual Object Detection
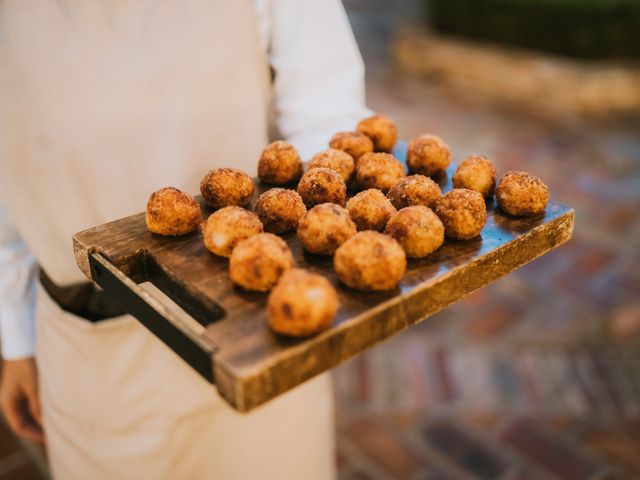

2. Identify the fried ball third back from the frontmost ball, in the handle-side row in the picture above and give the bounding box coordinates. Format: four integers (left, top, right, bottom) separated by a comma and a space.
203, 206, 262, 257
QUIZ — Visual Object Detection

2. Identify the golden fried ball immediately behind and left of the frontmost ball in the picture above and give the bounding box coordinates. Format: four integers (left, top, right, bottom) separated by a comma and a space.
229, 233, 294, 292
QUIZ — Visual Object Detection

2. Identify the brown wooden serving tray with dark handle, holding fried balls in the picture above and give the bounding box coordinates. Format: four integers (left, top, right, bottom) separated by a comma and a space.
73, 146, 574, 412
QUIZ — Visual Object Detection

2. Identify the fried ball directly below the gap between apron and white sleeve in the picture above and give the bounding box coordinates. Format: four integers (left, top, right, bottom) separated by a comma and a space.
258, 140, 302, 185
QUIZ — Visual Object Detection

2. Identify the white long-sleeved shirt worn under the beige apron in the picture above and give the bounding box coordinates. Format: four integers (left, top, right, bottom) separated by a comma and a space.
0, 0, 369, 359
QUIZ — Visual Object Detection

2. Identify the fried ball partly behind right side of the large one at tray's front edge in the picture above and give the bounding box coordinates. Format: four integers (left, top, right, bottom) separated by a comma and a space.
384, 205, 444, 258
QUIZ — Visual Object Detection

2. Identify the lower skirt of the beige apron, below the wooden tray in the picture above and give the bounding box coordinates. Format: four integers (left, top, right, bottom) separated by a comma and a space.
37, 289, 335, 480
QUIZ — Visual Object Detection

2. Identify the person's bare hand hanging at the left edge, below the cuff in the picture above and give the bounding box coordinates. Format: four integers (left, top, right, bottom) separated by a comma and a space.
0, 358, 44, 443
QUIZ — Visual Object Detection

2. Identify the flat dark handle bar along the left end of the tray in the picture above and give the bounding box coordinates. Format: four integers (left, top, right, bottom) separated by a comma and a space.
89, 252, 216, 383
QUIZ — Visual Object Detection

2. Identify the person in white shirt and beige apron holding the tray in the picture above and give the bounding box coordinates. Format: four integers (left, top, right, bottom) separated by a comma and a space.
0, 0, 369, 480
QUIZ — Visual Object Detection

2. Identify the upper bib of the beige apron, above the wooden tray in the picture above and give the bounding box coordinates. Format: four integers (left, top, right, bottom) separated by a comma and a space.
0, 0, 268, 285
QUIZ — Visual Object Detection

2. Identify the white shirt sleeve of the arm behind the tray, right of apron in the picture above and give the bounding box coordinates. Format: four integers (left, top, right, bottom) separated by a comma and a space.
269, 0, 371, 160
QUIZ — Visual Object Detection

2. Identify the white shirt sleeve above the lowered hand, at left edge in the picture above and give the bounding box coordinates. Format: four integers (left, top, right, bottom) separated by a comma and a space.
0, 205, 37, 360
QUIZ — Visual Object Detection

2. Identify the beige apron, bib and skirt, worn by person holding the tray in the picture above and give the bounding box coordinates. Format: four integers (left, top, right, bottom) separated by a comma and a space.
0, 0, 334, 480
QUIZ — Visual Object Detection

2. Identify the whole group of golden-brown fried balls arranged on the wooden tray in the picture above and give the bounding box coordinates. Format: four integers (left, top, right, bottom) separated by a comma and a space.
146, 114, 549, 337
